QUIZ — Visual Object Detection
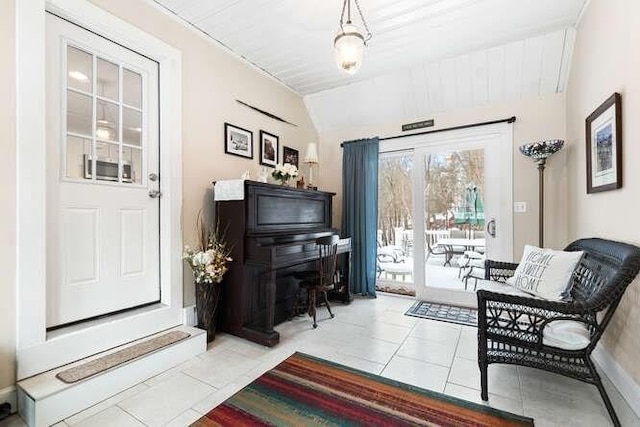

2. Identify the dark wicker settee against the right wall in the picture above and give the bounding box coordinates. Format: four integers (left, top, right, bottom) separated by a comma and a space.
477, 238, 640, 426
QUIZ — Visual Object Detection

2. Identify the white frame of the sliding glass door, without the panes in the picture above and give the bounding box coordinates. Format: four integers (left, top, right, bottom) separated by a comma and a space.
380, 123, 513, 306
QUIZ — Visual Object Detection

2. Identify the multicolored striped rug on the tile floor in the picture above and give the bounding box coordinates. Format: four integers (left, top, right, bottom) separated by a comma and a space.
192, 353, 533, 427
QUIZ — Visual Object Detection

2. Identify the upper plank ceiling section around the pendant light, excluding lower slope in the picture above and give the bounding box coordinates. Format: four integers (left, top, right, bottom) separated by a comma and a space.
156, 0, 588, 95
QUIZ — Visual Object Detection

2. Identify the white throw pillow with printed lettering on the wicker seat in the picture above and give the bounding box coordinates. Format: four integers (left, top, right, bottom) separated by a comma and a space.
507, 245, 583, 301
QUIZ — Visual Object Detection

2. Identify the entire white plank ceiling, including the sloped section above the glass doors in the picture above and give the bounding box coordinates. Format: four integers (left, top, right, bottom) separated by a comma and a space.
154, 0, 589, 131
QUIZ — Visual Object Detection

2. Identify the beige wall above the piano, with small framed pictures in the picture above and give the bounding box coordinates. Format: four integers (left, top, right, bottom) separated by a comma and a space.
92, 0, 317, 305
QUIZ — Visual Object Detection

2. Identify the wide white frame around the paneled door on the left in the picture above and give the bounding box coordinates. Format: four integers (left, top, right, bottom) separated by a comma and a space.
16, 0, 182, 380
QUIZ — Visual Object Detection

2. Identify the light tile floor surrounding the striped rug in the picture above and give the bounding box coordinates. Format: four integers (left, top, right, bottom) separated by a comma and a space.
5, 295, 640, 427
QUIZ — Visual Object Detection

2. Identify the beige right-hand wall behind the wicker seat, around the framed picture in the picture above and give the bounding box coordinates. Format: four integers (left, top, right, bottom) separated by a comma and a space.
567, 0, 640, 384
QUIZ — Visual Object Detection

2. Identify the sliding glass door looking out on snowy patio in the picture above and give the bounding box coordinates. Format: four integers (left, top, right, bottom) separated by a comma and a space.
378, 124, 513, 306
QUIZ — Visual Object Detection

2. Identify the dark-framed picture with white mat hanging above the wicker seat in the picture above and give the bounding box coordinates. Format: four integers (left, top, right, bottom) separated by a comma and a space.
586, 93, 622, 194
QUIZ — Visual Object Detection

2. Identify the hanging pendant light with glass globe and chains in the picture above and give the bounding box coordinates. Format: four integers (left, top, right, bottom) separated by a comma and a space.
333, 0, 372, 74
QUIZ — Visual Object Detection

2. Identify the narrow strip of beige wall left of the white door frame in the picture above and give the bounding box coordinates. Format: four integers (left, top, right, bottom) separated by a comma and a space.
0, 0, 16, 394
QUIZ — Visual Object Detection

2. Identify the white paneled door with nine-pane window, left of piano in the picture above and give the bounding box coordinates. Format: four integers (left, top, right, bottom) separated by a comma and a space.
46, 14, 160, 328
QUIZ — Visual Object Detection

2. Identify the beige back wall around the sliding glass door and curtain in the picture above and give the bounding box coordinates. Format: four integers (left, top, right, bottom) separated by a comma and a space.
320, 94, 568, 259
